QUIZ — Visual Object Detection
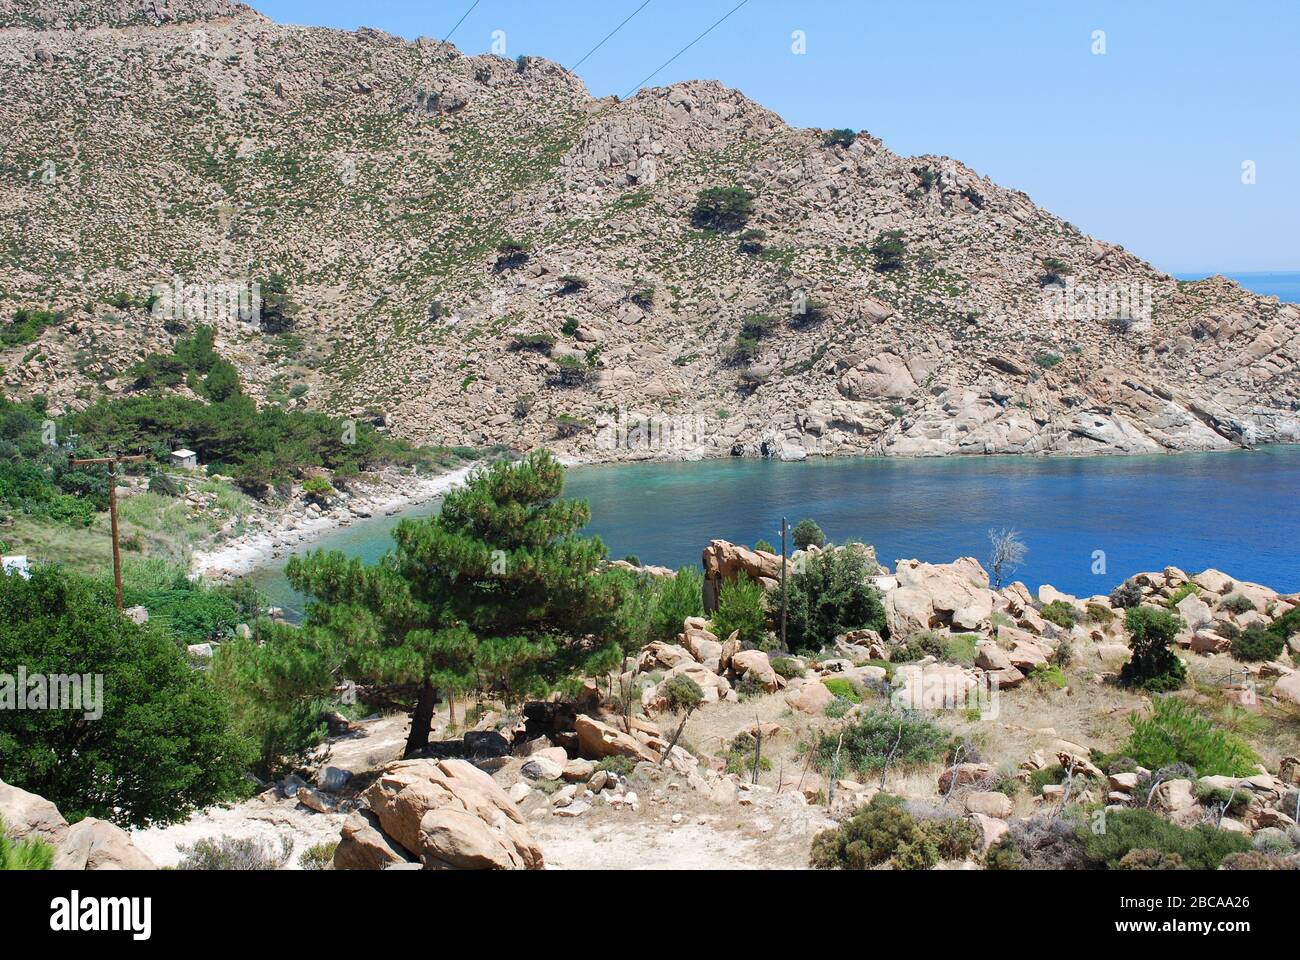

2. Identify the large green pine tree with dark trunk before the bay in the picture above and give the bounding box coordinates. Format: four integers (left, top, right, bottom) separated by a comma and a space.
286, 451, 627, 756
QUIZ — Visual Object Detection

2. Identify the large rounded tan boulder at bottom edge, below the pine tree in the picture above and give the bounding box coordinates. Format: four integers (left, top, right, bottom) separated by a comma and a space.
334, 760, 545, 870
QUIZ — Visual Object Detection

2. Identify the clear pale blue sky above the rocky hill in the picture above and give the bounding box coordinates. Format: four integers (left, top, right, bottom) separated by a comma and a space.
252, 0, 1300, 272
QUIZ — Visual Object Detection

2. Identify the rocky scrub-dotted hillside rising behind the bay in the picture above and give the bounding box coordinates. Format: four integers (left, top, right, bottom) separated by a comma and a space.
0, 0, 1300, 459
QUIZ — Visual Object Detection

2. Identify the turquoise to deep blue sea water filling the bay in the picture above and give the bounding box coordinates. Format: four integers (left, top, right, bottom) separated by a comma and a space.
248, 446, 1300, 614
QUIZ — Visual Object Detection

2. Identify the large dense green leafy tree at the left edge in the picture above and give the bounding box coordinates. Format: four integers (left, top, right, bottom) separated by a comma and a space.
0, 566, 252, 827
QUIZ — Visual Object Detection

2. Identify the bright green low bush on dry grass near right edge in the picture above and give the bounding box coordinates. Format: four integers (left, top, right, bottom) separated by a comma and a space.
1123, 697, 1260, 777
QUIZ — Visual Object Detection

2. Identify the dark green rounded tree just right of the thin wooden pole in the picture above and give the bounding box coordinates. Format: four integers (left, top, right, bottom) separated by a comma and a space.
787, 549, 887, 652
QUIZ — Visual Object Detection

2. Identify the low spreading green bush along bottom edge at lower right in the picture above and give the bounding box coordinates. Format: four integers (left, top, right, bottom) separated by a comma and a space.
1079, 810, 1251, 870
